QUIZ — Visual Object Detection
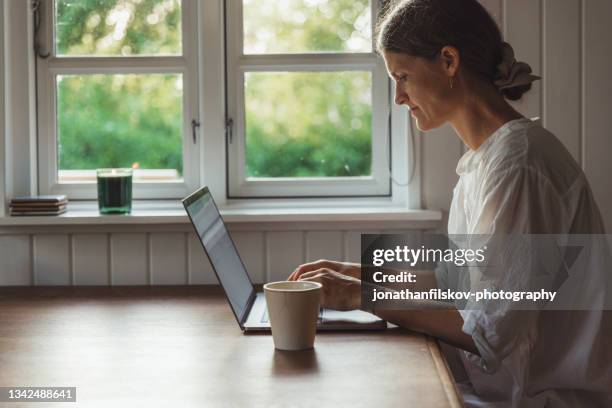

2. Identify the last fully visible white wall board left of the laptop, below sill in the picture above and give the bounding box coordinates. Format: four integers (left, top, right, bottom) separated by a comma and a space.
149, 233, 187, 285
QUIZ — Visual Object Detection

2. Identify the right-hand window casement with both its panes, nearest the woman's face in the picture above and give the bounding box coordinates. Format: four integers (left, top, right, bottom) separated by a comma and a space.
226, 0, 391, 197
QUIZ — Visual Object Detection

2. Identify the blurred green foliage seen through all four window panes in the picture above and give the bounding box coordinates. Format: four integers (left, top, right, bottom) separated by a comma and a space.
56, 0, 372, 177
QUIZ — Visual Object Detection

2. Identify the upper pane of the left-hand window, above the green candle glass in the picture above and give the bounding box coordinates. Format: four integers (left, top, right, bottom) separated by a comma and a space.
55, 0, 182, 56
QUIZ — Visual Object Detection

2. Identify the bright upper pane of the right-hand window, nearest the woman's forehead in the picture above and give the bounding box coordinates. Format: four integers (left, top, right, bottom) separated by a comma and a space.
243, 0, 372, 54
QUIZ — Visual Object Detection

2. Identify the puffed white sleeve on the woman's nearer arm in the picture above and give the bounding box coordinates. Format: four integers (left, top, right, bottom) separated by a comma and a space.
460, 165, 560, 373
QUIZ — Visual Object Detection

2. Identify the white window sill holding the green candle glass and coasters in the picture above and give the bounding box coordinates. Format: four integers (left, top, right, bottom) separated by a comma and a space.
0, 201, 442, 226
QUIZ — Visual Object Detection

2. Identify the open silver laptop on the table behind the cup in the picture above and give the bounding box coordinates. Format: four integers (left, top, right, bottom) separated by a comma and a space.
183, 187, 387, 332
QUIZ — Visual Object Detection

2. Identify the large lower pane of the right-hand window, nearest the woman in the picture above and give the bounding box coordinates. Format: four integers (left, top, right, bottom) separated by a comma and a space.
245, 71, 372, 177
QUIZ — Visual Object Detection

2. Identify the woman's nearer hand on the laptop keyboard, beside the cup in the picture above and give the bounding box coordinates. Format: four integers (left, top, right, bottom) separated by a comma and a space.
299, 268, 361, 310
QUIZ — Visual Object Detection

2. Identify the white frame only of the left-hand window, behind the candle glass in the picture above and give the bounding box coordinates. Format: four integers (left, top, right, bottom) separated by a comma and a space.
36, 0, 202, 199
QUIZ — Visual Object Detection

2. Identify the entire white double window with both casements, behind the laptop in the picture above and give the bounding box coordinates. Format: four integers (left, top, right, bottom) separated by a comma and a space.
24, 0, 406, 202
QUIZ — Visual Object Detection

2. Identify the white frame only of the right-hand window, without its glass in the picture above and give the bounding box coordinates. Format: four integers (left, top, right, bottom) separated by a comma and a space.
226, 0, 391, 198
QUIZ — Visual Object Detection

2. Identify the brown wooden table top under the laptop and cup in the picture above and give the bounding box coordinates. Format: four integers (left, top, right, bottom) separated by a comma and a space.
0, 287, 461, 408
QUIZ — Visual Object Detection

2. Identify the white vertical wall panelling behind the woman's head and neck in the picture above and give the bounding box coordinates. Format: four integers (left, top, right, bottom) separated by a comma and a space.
417, 0, 612, 231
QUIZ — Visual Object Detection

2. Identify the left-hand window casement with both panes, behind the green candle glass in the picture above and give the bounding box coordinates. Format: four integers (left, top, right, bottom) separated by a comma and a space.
37, 0, 201, 198
